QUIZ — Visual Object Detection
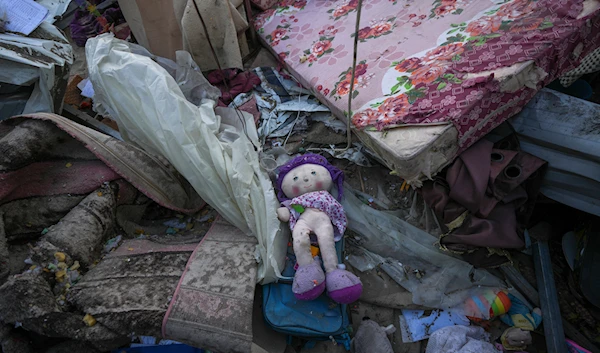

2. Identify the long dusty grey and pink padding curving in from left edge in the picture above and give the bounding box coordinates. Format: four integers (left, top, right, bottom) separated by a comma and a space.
0, 113, 204, 213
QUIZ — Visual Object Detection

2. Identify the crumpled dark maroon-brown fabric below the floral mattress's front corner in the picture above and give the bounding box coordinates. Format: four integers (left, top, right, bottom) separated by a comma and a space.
422, 136, 546, 267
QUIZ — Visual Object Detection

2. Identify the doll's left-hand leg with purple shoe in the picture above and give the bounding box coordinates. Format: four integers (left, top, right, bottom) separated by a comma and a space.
292, 219, 325, 300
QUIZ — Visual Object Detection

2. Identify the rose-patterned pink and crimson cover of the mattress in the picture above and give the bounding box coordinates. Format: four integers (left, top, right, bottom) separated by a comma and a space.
255, 0, 600, 160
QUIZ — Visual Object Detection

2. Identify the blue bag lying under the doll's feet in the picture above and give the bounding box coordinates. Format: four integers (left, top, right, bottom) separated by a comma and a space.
263, 239, 350, 351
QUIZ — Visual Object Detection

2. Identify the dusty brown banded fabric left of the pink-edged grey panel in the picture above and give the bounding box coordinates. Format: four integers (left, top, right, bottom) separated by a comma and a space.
67, 234, 197, 337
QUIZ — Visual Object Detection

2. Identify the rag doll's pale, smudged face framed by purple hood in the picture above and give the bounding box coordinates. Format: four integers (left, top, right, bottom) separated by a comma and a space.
281, 164, 333, 199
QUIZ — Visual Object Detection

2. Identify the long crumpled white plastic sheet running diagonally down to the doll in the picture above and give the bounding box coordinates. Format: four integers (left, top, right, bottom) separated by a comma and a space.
86, 34, 288, 283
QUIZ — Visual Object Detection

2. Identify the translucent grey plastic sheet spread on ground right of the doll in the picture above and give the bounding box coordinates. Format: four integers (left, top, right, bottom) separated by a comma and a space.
342, 185, 505, 310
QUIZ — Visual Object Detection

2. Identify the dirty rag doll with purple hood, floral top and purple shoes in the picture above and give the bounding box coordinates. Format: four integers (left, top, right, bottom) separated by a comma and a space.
277, 154, 362, 304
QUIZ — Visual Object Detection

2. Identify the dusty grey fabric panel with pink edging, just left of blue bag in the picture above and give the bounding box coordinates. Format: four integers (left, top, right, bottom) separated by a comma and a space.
162, 219, 257, 353
